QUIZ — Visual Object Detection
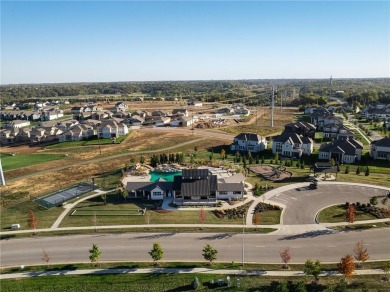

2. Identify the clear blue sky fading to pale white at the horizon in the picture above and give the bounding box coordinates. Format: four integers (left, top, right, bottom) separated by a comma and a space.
0, 0, 390, 84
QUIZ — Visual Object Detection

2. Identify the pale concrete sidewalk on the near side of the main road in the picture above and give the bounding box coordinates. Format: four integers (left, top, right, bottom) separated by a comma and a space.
0, 268, 385, 280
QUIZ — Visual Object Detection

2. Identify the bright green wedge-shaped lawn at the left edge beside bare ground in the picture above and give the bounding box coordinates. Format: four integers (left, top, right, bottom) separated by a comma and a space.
0, 153, 65, 171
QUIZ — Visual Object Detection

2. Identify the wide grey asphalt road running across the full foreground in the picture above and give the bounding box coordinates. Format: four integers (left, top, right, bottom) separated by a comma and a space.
0, 229, 390, 266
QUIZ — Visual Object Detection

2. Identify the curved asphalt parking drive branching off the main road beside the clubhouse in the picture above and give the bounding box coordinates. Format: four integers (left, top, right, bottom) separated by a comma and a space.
269, 183, 386, 225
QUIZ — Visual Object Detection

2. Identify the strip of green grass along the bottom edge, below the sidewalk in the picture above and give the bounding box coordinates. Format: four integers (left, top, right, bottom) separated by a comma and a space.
1, 274, 389, 292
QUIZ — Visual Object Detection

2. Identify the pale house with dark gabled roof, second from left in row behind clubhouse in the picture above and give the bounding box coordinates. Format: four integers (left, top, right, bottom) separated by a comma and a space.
272, 132, 314, 159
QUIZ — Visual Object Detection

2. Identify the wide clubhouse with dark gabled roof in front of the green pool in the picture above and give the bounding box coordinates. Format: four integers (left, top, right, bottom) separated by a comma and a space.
126, 169, 245, 205
